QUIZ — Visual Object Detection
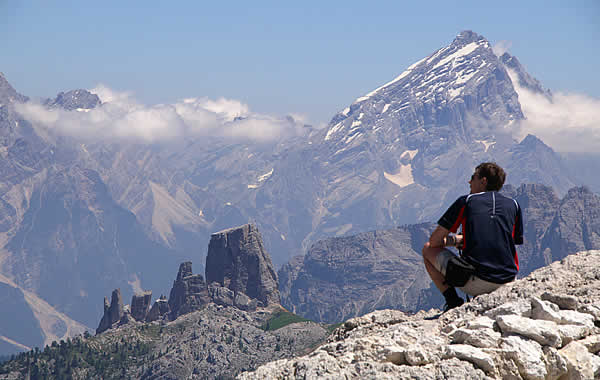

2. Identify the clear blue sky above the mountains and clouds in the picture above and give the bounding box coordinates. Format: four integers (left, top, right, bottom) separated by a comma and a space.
0, 0, 600, 124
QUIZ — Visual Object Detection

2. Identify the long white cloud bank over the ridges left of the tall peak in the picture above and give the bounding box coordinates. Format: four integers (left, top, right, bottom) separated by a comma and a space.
17, 85, 305, 142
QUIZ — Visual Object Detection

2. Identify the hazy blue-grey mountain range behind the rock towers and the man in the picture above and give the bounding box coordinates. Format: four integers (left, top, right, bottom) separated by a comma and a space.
0, 31, 598, 352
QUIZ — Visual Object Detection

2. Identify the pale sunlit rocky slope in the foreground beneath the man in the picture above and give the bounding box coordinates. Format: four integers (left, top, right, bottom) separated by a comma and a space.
239, 251, 600, 379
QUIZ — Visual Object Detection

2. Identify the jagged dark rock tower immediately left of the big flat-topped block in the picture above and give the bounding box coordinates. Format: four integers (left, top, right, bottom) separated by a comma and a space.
169, 261, 209, 319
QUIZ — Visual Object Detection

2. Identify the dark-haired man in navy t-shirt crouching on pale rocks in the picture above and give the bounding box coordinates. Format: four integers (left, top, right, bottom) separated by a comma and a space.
423, 162, 523, 311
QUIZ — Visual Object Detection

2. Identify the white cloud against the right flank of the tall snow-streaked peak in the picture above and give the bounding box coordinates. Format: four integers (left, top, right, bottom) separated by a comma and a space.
509, 70, 600, 152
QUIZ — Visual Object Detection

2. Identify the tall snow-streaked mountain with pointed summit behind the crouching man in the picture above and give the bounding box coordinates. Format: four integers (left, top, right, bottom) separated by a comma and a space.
312, 31, 573, 234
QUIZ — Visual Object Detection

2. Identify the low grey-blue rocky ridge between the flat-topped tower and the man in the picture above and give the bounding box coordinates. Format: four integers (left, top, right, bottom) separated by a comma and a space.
279, 224, 434, 322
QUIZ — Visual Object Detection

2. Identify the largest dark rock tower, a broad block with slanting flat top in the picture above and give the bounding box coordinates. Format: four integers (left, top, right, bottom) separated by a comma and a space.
206, 224, 280, 305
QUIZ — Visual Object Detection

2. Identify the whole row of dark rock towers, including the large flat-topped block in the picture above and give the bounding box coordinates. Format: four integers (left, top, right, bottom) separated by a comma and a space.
97, 224, 279, 333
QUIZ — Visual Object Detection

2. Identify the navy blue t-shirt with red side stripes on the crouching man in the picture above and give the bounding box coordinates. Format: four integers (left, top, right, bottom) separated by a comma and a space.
438, 191, 523, 284
